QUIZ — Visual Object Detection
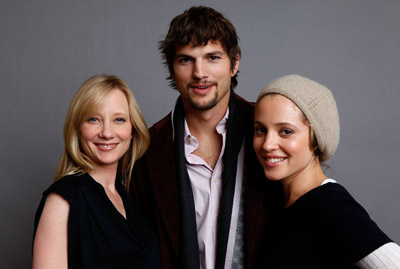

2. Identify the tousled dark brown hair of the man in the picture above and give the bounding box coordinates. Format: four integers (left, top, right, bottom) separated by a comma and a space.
159, 6, 241, 89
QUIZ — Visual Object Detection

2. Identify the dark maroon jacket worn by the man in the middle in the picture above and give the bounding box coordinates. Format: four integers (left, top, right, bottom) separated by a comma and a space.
130, 93, 281, 268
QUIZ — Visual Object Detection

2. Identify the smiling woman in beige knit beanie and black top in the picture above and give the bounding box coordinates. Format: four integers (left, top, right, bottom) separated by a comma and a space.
253, 75, 400, 269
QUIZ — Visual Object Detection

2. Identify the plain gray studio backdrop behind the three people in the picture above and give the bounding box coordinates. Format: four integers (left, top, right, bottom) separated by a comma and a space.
0, 0, 400, 268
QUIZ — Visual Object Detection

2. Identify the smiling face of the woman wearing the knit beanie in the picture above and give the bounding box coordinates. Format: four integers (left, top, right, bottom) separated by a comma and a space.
253, 94, 314, 182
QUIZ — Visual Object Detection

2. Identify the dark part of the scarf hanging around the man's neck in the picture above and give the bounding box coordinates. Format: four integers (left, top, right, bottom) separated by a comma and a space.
173, 90, 244, 269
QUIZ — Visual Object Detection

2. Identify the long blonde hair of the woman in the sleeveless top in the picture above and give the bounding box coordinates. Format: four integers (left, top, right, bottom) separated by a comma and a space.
54, 75, 150, 192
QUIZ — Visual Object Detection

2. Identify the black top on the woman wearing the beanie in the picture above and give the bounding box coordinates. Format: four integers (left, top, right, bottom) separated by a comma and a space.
260, 183, 392, 269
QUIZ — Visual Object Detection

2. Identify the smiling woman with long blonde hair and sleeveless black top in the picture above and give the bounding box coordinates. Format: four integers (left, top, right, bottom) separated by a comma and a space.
33, 75, 159, 268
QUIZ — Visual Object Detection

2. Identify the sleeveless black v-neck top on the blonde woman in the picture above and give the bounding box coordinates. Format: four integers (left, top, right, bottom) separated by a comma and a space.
34, 173, 160, 268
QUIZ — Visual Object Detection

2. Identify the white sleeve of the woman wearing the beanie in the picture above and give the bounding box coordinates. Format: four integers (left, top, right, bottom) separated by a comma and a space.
356, 242, 400, 269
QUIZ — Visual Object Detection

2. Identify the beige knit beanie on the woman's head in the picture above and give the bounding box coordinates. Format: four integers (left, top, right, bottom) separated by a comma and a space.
257, 75, 340, 161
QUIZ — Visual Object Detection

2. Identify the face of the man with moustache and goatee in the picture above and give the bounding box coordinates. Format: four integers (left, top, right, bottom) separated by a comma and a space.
172, 41, 239, 110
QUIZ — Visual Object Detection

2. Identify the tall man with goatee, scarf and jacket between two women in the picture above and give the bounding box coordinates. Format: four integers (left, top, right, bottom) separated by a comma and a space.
131, 6, 282, 268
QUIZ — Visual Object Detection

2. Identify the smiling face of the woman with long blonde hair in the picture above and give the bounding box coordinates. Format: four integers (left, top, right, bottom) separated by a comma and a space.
79, 89, 132, 170
